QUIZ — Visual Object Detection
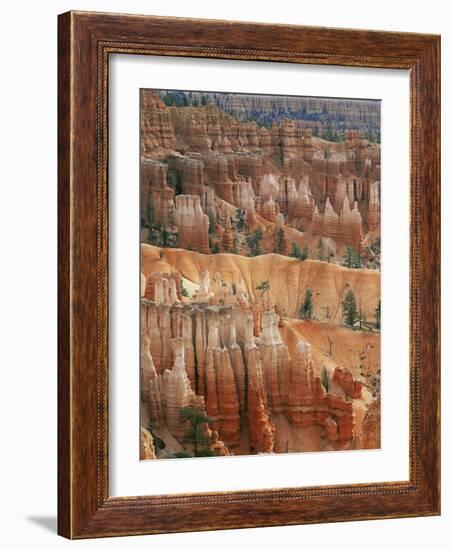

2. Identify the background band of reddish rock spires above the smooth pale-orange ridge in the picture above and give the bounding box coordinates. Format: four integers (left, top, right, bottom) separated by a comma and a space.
141, 91, 380, 267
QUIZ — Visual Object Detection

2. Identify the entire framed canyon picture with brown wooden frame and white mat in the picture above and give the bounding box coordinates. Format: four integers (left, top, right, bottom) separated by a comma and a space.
58, 12, 440, 538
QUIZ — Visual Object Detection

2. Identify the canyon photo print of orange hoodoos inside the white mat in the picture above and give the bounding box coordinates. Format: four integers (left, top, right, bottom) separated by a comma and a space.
137, 89, 381, 460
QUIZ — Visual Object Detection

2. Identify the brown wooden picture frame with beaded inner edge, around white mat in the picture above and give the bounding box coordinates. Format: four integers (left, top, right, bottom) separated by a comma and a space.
58, 12, 440, 538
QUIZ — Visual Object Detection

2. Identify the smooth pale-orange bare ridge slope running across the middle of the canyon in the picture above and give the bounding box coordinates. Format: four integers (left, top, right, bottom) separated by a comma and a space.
141, 244, 380, 325
